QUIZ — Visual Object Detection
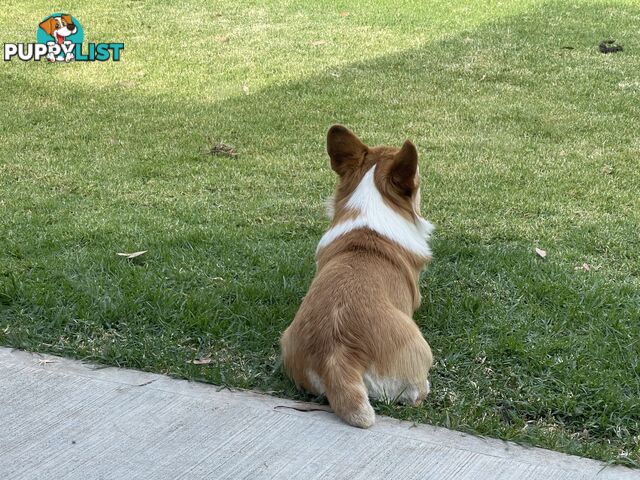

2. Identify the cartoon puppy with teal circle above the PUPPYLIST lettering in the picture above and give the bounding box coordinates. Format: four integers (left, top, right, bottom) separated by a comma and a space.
36, 13, 84, 62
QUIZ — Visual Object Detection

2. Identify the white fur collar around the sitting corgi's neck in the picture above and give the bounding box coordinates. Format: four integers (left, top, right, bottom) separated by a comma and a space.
316, 165, 434, 257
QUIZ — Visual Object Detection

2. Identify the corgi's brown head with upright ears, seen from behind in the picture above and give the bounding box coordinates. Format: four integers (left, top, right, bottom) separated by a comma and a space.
327, 125, 421, 223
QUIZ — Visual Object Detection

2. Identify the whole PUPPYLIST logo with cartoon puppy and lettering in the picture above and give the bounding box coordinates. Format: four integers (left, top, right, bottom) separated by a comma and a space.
4, 13, 124, 62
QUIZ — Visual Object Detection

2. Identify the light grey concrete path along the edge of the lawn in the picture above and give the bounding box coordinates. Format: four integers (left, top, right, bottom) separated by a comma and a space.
0, 348, 640, 480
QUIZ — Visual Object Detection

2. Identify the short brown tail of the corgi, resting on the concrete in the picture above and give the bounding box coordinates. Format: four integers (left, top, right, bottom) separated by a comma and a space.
323, 352, 376, 428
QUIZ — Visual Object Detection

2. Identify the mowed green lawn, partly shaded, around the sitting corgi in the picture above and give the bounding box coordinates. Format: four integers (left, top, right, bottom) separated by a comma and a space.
0, 0, 640, 465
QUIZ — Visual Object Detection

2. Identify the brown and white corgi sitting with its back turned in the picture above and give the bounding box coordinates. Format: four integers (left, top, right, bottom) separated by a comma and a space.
280, 125, 433, 428
